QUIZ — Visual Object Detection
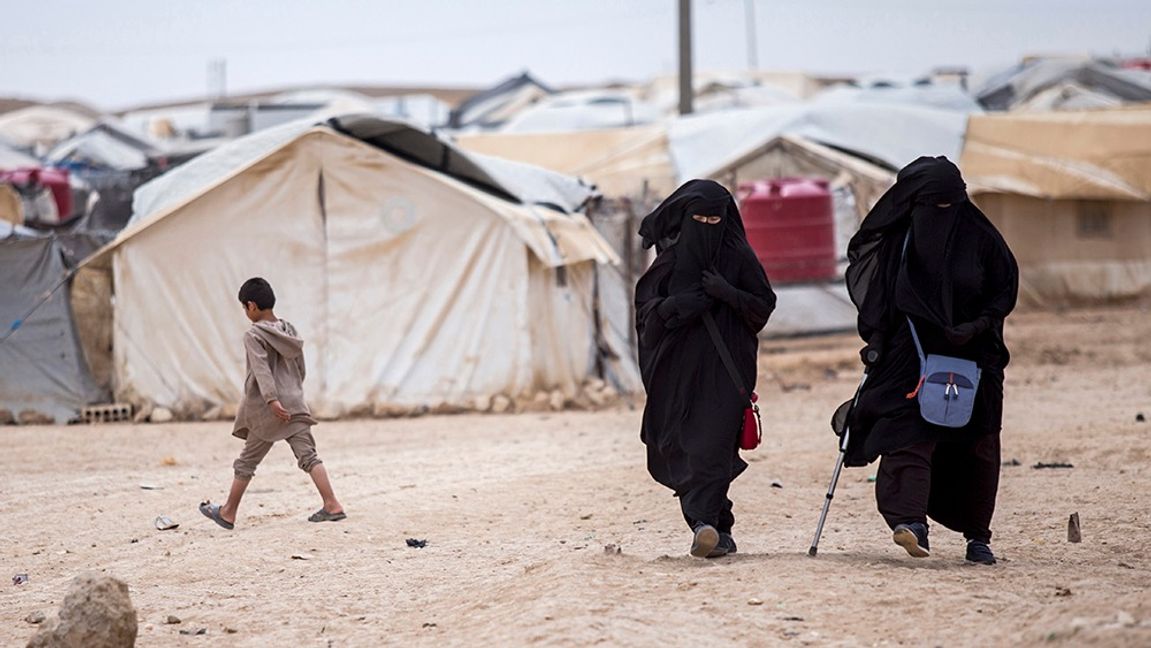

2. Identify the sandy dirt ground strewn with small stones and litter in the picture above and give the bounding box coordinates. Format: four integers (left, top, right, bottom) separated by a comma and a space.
0, 310, 1151, 647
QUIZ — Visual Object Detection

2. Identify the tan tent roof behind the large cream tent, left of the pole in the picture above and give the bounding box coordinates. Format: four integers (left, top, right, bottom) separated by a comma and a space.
457, 125, 677, 197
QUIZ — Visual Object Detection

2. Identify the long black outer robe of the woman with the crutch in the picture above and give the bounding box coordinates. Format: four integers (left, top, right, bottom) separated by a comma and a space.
846, 158, 1019, 466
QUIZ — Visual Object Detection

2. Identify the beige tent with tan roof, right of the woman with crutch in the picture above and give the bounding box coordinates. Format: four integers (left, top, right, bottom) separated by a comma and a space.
961, 107, 1151, 305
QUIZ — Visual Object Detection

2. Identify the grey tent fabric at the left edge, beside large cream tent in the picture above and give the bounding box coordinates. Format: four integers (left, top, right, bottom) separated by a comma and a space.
0, 228, 104, 424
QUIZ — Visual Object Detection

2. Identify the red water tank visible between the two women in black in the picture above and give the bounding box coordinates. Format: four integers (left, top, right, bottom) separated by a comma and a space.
737, 177, 836, 283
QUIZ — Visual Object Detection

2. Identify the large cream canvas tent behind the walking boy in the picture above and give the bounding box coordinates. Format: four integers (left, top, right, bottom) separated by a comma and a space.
85, 120, 634, 417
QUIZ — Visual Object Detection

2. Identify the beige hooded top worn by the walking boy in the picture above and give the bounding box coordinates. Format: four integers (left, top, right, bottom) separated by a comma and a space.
231, 320, 315, 441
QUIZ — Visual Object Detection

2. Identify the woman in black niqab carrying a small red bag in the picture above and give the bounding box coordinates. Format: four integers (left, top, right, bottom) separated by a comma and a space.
635, 180, 776, 557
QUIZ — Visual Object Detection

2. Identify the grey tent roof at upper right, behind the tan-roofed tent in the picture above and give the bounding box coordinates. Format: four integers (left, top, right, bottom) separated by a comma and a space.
975, 60, 1151, 110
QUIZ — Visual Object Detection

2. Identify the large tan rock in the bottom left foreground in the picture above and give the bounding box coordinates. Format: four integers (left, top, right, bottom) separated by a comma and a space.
28, 573, 137, 648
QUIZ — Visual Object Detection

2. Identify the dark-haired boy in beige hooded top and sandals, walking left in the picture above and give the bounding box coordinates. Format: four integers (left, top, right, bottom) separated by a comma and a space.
200, 277, 348, 529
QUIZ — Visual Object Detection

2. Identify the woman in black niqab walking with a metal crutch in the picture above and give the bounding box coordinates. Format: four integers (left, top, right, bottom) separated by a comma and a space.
846, 157, 1019, 564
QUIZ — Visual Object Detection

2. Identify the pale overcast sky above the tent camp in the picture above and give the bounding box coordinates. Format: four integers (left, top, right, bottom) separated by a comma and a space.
0, 0, 1151, 109
